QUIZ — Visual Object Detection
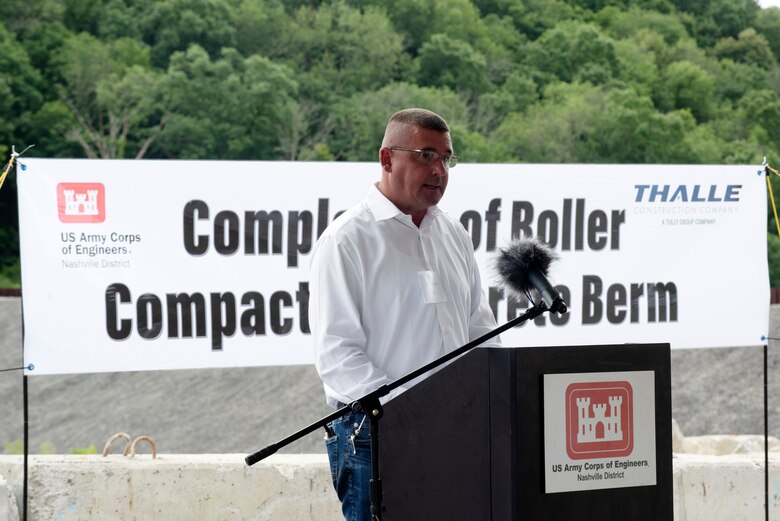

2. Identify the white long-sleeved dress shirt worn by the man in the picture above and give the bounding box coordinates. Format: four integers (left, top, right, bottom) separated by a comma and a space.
309, 186, 500, 407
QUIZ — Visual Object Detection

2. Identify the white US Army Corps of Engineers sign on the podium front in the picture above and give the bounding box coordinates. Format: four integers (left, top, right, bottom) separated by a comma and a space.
543, 371, 658, 494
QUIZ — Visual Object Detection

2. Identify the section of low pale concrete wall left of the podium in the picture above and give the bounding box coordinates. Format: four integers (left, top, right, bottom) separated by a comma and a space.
0, 454, 339, 521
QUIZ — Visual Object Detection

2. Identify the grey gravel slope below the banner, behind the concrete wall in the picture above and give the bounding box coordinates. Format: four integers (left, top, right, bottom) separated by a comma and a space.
0, 297, 780, 454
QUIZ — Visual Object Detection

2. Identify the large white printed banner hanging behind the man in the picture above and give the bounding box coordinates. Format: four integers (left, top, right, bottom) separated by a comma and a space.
18, 159, 769, 374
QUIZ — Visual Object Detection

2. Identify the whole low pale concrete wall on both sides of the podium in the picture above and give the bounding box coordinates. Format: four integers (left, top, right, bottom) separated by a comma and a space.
0, 452, 780, 521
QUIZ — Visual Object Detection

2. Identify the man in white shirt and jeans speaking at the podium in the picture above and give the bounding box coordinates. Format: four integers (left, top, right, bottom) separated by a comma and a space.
309, 109, 498, 521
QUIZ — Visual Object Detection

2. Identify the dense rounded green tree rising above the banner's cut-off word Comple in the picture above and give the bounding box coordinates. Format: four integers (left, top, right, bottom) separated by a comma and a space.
154, 45, 297, 159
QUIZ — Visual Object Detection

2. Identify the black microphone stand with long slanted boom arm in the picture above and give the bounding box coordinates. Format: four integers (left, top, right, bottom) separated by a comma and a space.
244, 297, 566, 521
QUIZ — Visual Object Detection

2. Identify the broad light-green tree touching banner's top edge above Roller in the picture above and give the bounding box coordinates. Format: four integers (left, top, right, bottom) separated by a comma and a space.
492, 83, 702, 163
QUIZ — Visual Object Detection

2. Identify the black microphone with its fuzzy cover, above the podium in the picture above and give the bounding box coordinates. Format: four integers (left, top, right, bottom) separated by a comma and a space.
495, 239, 568, 315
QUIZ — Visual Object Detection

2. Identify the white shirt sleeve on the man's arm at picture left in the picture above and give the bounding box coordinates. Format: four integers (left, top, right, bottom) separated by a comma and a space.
309, 232, 391, 407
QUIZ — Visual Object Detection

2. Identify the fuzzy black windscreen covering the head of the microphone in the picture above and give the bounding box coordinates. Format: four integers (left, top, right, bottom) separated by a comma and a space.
495, 239, 558, 295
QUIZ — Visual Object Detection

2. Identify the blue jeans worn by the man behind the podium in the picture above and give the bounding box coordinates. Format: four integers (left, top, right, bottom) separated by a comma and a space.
325, 412, 371, 521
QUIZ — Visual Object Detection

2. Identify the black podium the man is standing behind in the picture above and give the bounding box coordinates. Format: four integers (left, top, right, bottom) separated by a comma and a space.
379, 344, 673, 521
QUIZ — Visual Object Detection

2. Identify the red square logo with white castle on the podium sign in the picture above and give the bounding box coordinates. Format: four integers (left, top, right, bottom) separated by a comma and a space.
566, 381, 634, 460
